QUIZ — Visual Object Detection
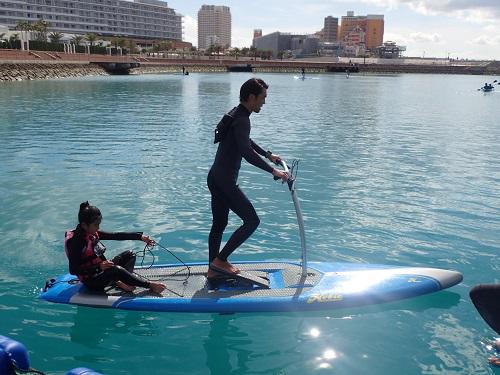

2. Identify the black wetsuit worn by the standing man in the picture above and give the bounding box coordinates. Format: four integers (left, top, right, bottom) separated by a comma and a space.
207, 104, 273, 262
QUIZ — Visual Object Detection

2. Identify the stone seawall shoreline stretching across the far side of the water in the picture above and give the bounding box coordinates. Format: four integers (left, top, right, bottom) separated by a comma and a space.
0, 55, 500, 82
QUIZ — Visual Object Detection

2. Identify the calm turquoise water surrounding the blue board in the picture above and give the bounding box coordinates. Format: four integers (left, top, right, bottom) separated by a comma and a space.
0, 74, 500, 375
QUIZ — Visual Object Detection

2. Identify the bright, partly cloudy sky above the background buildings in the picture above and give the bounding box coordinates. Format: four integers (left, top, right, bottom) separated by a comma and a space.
167, 0, 500, 60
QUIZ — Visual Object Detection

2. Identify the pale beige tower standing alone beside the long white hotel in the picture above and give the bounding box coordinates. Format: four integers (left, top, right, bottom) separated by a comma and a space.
198, 5, 231, 49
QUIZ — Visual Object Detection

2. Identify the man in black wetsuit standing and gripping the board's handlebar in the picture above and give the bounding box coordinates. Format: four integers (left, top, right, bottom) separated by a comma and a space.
207, 78, 288, 278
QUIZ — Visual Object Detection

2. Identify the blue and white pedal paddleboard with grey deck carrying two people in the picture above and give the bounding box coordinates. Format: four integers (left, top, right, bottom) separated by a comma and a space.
40, 261, 462, 312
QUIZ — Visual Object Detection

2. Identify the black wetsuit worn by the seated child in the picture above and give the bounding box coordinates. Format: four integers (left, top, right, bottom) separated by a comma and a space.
66, 226, 149, 290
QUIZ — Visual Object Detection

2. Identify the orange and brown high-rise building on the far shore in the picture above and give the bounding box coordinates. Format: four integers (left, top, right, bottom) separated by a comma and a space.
339, 11, 384, 51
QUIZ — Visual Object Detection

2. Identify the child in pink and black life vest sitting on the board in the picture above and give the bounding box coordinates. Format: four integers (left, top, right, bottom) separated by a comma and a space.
64, 202, 166, 293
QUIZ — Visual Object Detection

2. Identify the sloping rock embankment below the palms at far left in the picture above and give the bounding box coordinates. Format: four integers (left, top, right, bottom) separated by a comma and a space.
0, 62, 108, 81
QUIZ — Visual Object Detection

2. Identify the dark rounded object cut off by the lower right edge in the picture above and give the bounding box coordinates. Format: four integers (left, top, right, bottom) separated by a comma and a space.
469, 284, 500, 335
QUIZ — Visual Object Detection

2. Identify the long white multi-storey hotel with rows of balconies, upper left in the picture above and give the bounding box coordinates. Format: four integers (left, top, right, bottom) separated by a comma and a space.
0, 0, 182, 40
